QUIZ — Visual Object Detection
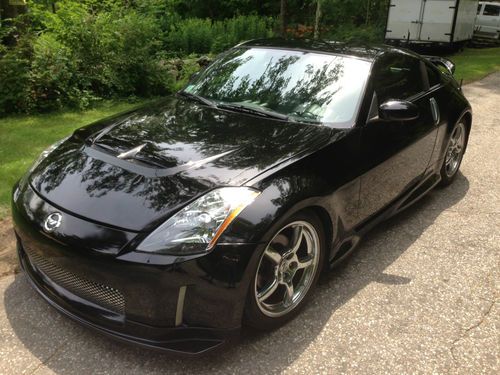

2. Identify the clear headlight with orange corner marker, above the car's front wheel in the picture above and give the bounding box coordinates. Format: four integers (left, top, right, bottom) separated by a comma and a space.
137, 187, 260, 255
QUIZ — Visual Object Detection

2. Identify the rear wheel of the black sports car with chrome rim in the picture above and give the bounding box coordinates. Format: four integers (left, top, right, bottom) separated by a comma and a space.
440, 120, 467, 187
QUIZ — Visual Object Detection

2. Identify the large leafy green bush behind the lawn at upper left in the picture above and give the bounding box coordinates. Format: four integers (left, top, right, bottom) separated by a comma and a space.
0, 0, 175, 114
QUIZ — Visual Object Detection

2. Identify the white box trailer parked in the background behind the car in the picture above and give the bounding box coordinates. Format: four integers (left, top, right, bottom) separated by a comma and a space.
385, 0, 478, 46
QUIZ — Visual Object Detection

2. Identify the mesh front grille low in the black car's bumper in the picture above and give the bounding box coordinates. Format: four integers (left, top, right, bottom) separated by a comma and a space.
24, 248, 125, 315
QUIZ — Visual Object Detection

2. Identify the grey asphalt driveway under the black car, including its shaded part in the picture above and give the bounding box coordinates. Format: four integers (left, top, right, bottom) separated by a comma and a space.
0, 73, 500, 375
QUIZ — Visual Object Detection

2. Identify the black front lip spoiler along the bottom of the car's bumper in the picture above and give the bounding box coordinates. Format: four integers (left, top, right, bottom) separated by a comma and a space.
17, 244, 240, 357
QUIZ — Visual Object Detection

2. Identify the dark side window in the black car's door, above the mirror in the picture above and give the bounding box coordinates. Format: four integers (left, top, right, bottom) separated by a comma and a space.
373, 54, 424, 103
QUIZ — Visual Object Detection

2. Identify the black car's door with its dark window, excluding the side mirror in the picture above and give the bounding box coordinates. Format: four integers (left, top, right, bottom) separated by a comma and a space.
359, 53, 439, 220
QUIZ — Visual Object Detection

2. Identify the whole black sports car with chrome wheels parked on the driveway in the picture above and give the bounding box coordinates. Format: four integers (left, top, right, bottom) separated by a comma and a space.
12, 40, 472, 354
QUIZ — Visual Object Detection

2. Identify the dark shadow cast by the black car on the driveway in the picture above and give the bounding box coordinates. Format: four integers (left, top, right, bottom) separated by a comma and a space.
5, 174, 469, 374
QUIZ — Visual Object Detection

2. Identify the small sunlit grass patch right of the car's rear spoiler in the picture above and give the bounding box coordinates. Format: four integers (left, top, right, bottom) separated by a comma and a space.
448, 48, 500, 83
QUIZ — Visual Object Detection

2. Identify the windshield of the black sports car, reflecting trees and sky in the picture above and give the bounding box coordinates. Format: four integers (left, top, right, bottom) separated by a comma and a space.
184, 48, 371, 125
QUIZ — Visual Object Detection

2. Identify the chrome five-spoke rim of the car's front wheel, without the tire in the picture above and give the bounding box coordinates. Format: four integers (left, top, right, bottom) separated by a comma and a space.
254, 221, 320, 318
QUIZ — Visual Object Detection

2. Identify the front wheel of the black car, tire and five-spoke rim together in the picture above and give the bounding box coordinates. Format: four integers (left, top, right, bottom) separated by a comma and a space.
244, 212, 326, 330
